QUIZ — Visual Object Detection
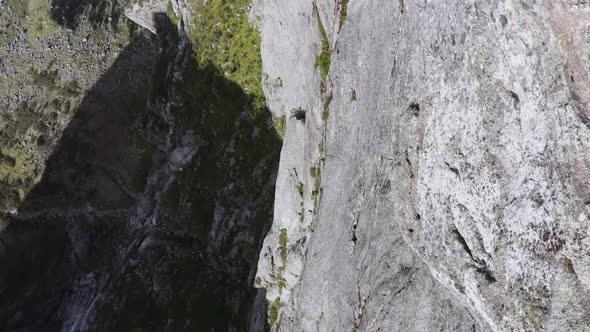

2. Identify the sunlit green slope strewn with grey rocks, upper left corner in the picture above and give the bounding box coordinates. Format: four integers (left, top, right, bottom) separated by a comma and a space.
0, 0, 129, 215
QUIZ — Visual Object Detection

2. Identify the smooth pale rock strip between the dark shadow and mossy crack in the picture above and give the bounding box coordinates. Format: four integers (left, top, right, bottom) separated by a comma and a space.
252, 0, 323, 322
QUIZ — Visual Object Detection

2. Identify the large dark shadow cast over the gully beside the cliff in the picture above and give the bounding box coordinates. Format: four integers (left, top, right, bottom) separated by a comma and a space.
0, 11, 281, 331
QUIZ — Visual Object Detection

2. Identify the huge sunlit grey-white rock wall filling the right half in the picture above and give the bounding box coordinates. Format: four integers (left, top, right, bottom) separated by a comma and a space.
257, 0, 590, 331
